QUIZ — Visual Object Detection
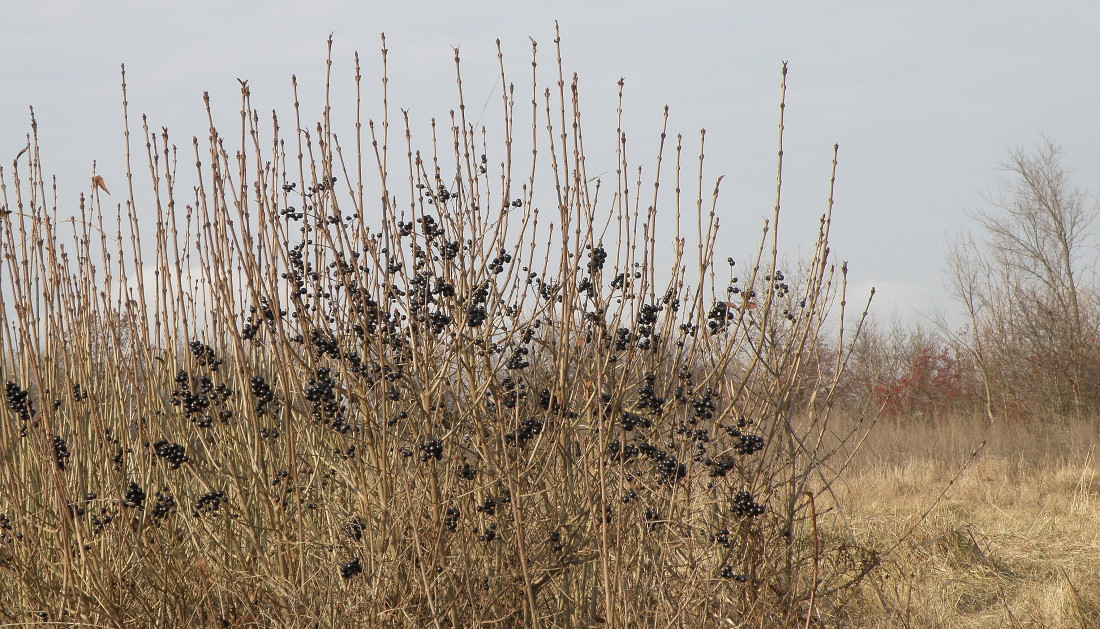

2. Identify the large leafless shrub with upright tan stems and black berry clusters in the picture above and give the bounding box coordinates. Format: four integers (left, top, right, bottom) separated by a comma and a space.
0, 31, 880, 627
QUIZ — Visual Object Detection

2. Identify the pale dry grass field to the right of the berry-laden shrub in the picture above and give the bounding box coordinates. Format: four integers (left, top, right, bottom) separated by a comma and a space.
836, 417, 1100, 629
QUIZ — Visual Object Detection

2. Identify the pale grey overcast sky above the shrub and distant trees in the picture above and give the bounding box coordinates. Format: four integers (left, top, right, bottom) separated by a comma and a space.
0, 0, 1100, 323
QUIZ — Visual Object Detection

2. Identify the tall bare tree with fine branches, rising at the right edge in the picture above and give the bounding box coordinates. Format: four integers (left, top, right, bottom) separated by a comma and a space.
947, 139, 1100, 419
